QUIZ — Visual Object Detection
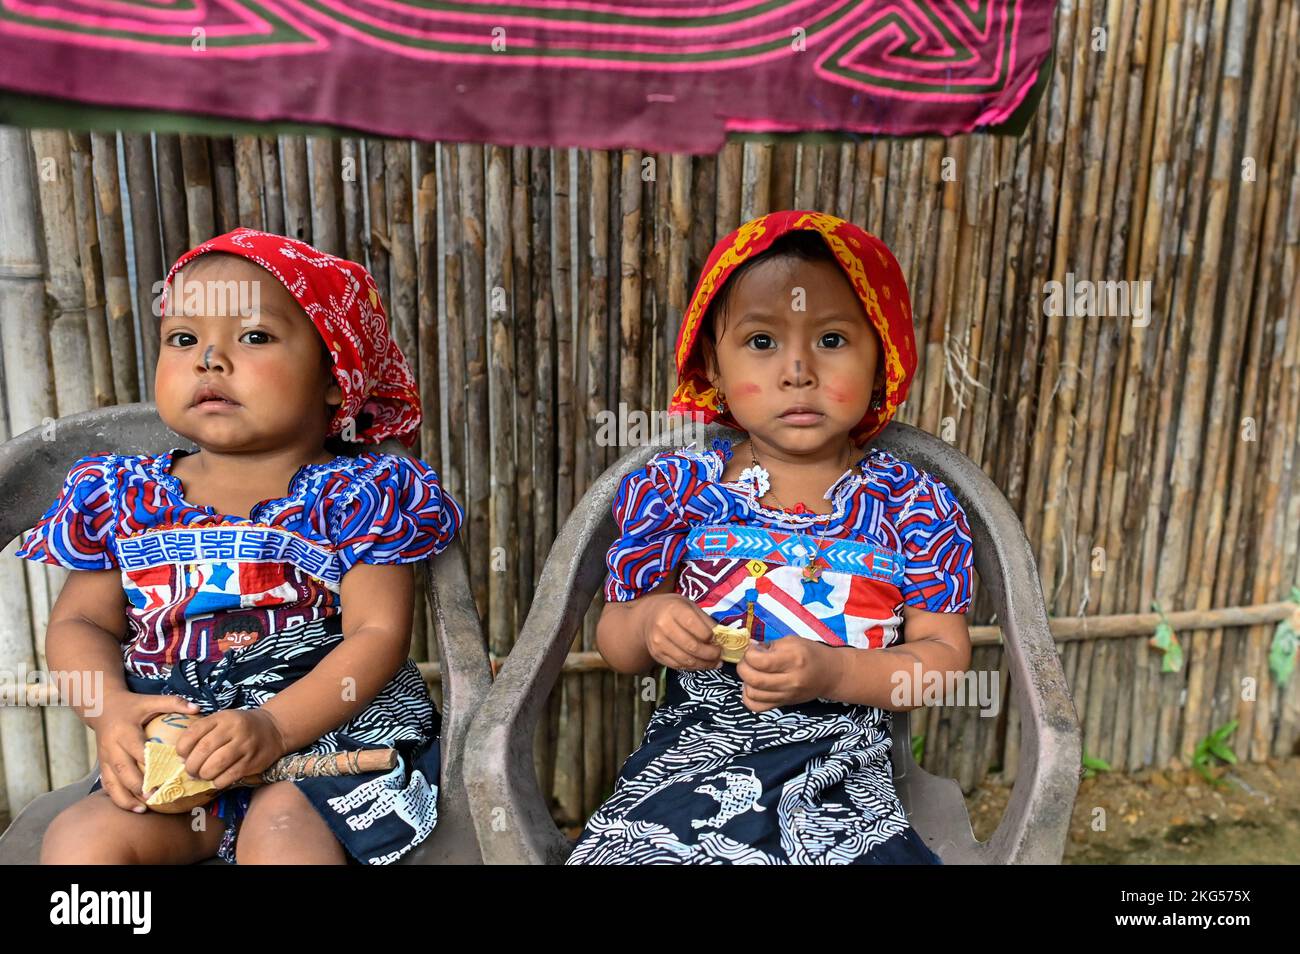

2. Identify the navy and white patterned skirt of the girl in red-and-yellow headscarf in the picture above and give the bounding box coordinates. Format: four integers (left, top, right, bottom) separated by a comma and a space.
568, 664, 941, 864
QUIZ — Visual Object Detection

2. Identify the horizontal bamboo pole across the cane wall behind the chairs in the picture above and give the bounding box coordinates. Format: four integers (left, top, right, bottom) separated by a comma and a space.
0, 600, 1300, 706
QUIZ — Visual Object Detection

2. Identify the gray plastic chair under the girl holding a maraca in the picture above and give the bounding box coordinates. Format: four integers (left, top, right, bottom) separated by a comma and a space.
0, 404, 491, 864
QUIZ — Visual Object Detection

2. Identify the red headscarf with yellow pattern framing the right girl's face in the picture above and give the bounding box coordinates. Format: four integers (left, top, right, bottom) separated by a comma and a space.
668, 209, 917, 447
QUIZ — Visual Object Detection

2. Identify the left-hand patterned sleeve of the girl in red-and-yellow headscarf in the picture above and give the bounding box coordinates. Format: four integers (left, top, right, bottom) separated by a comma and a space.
605, 456, 692, 603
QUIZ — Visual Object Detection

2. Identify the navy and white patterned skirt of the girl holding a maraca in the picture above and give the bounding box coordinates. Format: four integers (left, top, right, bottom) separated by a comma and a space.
90, 616, 442, 864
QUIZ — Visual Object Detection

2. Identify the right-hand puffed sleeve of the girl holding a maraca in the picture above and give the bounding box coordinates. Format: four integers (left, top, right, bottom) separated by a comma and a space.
330, 454, 464, 573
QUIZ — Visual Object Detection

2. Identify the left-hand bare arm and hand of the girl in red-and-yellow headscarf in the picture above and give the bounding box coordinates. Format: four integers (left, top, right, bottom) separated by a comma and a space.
595, 567, 722, 675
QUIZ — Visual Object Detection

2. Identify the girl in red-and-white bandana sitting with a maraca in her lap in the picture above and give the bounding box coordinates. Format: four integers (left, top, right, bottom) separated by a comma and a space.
20, 229, 462, 864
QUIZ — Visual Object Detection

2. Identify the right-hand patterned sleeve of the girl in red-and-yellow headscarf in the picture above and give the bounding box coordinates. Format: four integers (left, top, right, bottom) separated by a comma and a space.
898, 474, 975, 613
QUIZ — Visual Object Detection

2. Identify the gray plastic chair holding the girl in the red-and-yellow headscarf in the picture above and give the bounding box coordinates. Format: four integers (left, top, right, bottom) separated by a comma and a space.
465, 422, 1080, 864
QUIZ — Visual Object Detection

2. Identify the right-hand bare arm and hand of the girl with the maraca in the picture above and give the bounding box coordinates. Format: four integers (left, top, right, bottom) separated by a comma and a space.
177, 563, 415, 788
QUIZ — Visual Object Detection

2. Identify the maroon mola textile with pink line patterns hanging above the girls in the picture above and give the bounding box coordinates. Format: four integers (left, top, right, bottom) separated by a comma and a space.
0, 0, 1054, 152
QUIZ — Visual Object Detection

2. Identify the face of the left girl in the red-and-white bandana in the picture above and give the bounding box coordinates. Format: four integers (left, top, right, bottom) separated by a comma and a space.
155, 252, 343, 452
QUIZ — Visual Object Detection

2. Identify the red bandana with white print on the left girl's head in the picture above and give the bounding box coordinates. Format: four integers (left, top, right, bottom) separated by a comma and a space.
163, 227, 421, 447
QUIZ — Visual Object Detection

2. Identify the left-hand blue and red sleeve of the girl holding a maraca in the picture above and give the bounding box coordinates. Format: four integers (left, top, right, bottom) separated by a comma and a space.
16, 455, 117, 569
